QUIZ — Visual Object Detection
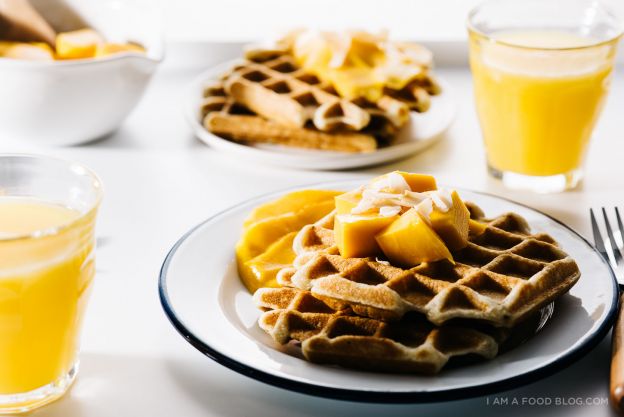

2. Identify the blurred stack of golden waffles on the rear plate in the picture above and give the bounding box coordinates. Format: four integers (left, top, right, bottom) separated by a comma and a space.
201, 48, 440, 152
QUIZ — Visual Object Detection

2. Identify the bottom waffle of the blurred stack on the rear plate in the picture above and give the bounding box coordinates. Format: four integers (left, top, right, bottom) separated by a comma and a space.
201, 81, 377, 152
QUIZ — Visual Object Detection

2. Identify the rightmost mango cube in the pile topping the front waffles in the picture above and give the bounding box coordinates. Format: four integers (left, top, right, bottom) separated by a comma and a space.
429, 191, 470, 251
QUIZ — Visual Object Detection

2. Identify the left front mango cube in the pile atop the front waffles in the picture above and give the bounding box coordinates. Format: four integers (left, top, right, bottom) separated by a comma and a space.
334, 214, 399, 258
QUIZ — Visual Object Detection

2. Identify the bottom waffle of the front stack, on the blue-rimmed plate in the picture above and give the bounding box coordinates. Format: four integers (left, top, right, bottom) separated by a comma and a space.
254, 288, 504, 374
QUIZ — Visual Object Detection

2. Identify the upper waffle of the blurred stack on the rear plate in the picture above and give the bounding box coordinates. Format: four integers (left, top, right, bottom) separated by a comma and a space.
226, 49, 409, 134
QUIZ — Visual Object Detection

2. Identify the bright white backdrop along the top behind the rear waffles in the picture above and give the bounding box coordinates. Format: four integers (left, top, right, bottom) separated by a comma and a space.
165, 0, 624, 41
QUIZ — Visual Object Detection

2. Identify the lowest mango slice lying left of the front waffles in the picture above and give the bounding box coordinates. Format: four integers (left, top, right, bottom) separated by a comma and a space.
238, 232, 297, 292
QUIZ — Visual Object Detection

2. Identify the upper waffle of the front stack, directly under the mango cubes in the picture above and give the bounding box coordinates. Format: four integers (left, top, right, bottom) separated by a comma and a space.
277, 205, 580, 327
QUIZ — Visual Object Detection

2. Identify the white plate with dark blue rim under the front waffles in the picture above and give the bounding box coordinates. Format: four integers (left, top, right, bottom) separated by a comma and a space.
159, 181, 617, 402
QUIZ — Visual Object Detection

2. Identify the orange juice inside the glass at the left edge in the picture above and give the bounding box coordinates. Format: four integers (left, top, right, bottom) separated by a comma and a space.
0, 197, 95, 395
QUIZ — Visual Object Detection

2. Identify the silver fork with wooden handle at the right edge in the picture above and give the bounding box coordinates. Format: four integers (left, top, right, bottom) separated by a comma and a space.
589, 207, 624, 414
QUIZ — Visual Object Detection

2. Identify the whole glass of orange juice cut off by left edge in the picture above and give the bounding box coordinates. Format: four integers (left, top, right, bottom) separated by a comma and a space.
0, 155, 102, 414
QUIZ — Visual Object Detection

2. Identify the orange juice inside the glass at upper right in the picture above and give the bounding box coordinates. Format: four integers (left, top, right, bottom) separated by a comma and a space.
470, 31, 614, 176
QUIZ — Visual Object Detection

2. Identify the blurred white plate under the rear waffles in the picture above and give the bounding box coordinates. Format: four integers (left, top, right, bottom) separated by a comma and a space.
185, 60, 457, 170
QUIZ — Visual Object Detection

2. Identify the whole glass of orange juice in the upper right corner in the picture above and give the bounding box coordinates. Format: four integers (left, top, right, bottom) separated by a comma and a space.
468, 0, 622, 192
